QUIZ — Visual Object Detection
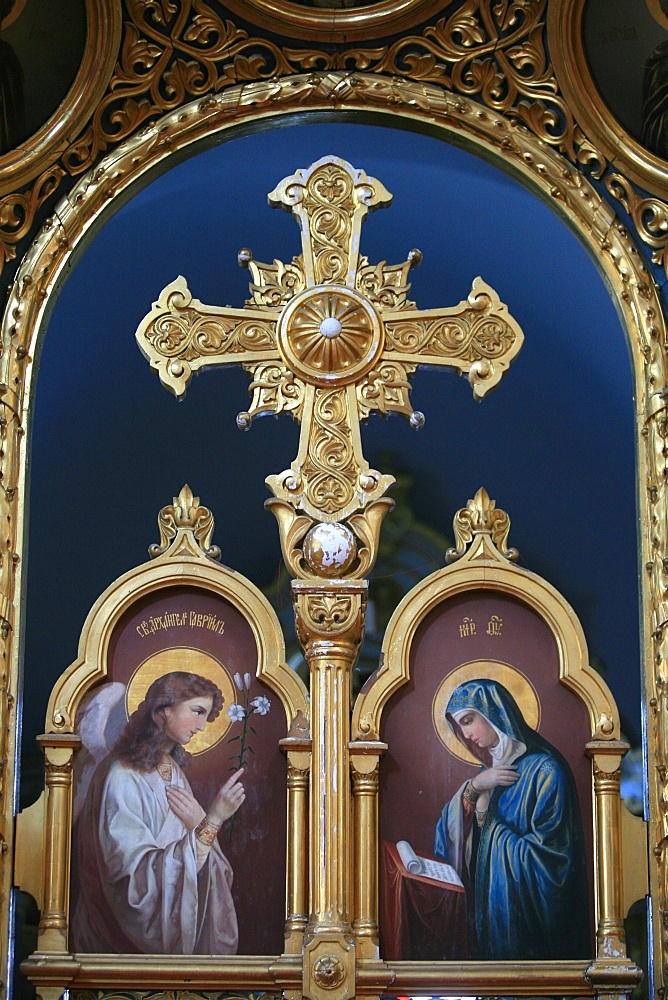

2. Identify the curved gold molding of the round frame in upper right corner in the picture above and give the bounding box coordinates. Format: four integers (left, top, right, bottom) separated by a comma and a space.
547, 0, 668, 197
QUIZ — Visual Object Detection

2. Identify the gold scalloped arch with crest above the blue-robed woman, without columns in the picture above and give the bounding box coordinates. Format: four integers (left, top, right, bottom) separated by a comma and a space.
352, 490, 620, 740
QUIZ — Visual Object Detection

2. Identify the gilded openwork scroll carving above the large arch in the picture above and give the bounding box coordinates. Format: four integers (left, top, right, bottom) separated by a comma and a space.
0, 0, 666, 284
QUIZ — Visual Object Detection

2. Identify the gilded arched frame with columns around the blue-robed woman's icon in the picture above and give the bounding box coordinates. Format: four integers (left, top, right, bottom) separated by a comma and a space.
351, 488, 644, 994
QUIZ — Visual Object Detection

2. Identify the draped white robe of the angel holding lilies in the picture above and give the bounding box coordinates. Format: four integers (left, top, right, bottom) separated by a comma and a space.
70, 760, 238, 955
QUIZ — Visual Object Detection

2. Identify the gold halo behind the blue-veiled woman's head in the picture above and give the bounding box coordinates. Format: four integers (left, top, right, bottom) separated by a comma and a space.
432, 660, 540, 764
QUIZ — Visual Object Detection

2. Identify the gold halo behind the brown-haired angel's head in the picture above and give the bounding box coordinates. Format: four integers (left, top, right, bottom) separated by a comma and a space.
125, 646, 236, 756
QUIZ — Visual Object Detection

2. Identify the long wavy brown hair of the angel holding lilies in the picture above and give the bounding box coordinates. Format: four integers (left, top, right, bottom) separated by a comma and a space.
112, 670, 223, 773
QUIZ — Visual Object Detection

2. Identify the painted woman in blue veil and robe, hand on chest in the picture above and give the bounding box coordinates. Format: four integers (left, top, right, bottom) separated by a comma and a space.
434, 679, 591, 960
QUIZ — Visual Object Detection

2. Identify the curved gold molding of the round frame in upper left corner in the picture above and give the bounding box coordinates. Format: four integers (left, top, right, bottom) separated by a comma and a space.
0, 0, 122, 195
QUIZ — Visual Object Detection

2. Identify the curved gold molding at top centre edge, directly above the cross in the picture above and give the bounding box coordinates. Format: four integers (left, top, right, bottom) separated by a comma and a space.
222, 0, 443, 43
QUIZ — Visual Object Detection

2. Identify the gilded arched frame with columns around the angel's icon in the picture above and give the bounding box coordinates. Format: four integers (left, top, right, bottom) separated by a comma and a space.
19, 487, 310, 976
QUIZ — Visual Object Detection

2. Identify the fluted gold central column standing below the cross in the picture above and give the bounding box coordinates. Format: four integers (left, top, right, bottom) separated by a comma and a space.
292, 580, 367, 1000
